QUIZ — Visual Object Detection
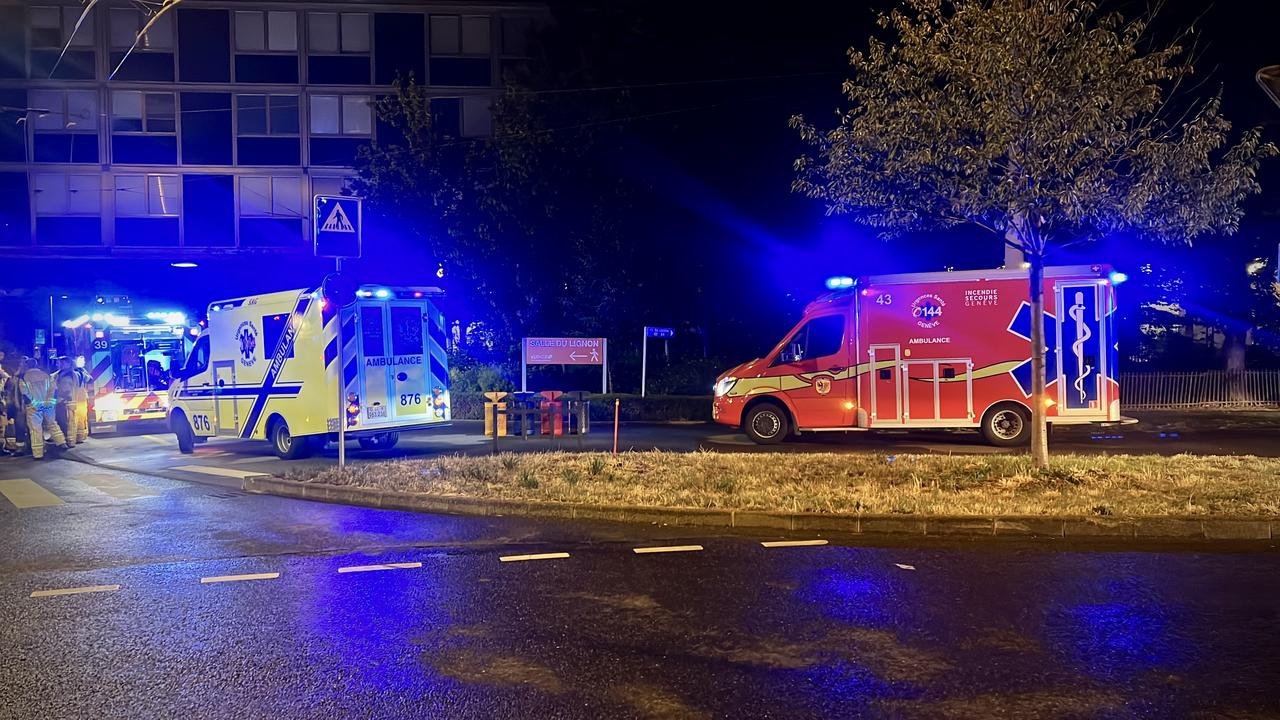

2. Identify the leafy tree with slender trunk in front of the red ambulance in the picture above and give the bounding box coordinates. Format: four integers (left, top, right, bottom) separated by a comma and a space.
791, 0, 1276, 466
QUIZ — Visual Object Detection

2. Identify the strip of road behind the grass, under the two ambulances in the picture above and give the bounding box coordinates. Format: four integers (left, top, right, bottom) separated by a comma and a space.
52, 411, 1280, 487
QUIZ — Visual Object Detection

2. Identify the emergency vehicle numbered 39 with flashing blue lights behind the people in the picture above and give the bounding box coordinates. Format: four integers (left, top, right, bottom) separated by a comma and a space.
63, 306, 198, 432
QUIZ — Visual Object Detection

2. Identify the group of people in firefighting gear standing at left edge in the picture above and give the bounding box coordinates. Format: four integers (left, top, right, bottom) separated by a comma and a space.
0, 352, 91, 460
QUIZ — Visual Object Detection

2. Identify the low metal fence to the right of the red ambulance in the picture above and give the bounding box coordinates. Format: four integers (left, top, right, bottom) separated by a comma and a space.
1120, 370, 1280, 410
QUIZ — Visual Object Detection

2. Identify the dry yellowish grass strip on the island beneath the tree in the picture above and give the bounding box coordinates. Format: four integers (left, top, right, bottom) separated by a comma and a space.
293, 451, 1280, 516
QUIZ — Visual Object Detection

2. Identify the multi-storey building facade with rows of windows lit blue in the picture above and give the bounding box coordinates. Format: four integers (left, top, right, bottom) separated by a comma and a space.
0, 0, 545, 258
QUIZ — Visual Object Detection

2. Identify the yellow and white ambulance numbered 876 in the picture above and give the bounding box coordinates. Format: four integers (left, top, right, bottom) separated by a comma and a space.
169, 283, 451, 460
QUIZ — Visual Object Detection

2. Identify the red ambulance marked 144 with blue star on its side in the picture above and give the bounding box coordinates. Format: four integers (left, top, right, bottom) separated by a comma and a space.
712, 265, 1124, 446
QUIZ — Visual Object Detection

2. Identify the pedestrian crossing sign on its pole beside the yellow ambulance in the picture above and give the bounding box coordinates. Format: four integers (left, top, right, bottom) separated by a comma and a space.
311, 195, 364, 469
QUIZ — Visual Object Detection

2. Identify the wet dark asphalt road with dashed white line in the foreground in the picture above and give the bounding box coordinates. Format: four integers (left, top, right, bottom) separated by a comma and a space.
0, 450, 1280, 719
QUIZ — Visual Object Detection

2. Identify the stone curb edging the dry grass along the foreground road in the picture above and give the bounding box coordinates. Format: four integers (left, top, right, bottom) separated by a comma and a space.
241, 475, 1280, 542
